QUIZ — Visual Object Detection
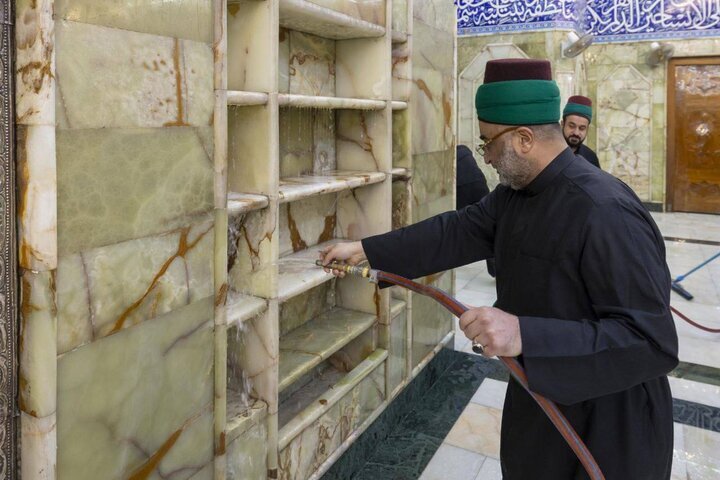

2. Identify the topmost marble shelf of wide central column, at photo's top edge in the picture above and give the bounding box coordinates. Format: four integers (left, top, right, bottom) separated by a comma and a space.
280, 0, 385, 40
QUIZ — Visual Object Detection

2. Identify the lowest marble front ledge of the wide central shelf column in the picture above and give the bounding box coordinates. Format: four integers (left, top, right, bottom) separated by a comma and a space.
278, 348, 388, 450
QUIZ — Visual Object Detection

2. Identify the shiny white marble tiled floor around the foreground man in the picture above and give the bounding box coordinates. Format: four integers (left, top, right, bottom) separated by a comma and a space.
422, 213, 720, 480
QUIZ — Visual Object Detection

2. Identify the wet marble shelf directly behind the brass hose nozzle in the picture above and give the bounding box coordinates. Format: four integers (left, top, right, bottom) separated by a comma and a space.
278, 239, 346, 302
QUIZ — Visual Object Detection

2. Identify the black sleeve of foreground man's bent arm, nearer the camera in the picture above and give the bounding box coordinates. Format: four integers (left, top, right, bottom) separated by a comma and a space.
520, 202, 678, 405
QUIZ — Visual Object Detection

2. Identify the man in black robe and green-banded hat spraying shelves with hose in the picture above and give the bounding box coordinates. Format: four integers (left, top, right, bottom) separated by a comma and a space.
321, 59, 678, 480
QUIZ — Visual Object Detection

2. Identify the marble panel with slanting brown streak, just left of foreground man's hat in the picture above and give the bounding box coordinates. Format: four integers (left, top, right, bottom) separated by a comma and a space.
410, 67, 455, 154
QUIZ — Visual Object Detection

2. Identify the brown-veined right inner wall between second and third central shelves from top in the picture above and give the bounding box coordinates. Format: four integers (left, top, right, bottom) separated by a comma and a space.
336, 110, 392, 172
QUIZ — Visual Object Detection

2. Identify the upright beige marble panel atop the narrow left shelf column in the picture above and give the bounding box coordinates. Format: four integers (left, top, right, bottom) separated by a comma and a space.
227, 0, 277, 92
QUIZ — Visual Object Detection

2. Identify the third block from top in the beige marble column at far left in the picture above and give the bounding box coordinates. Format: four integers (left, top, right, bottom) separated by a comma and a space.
18, 270, 57, 418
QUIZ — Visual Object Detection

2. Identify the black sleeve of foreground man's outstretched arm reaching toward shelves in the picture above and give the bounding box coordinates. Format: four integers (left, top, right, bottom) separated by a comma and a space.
362, 189, 498, 286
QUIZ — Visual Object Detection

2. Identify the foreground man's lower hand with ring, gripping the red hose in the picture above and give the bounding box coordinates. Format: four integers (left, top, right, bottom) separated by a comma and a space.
460, 307, 522, 357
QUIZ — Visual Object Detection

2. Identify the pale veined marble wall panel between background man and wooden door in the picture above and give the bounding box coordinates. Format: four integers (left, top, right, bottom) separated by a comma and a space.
597, 62, 652, 200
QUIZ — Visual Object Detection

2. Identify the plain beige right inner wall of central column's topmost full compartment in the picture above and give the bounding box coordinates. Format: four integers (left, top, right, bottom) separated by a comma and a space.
335, 37, 392, 100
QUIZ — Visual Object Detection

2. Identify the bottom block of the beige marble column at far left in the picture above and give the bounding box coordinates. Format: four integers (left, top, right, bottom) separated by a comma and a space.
20, 411, 57, 480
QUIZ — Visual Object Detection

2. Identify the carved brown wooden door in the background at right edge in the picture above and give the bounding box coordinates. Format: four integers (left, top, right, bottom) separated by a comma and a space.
667, 57, 720, 213
